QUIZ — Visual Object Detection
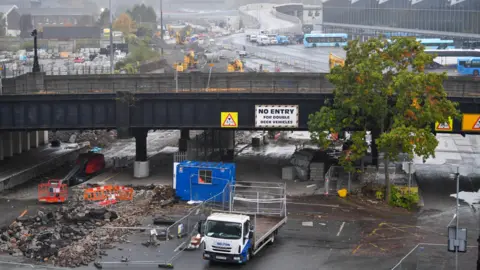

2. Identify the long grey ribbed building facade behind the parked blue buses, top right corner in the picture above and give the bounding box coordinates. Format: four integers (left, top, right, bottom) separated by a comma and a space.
323, 0, 480, 34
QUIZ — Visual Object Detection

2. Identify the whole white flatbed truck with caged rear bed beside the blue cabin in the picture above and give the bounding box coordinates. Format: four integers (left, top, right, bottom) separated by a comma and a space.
200, 183, 287, 264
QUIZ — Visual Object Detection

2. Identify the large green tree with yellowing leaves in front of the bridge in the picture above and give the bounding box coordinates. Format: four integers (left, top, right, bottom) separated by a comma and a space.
308, 38, 459, 202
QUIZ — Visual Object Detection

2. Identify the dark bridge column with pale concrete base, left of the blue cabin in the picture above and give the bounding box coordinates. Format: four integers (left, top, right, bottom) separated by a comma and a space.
133, 129, 150, 178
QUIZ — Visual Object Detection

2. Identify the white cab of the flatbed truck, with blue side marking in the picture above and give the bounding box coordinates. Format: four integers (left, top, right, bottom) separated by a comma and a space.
203, 213, 253, 263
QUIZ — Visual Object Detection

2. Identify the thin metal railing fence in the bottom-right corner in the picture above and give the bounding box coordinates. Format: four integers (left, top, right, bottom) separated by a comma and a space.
392, 243, 478, 270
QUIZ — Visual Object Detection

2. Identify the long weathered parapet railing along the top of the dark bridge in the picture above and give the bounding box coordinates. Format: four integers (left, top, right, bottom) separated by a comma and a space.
2, 72, 480, 97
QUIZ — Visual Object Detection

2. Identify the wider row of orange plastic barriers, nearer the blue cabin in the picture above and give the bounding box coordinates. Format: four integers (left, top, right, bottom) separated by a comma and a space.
83, 186, 133, 201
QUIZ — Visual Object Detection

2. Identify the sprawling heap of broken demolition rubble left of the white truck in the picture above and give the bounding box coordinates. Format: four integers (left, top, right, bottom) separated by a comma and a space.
0, 187, 174, 267
